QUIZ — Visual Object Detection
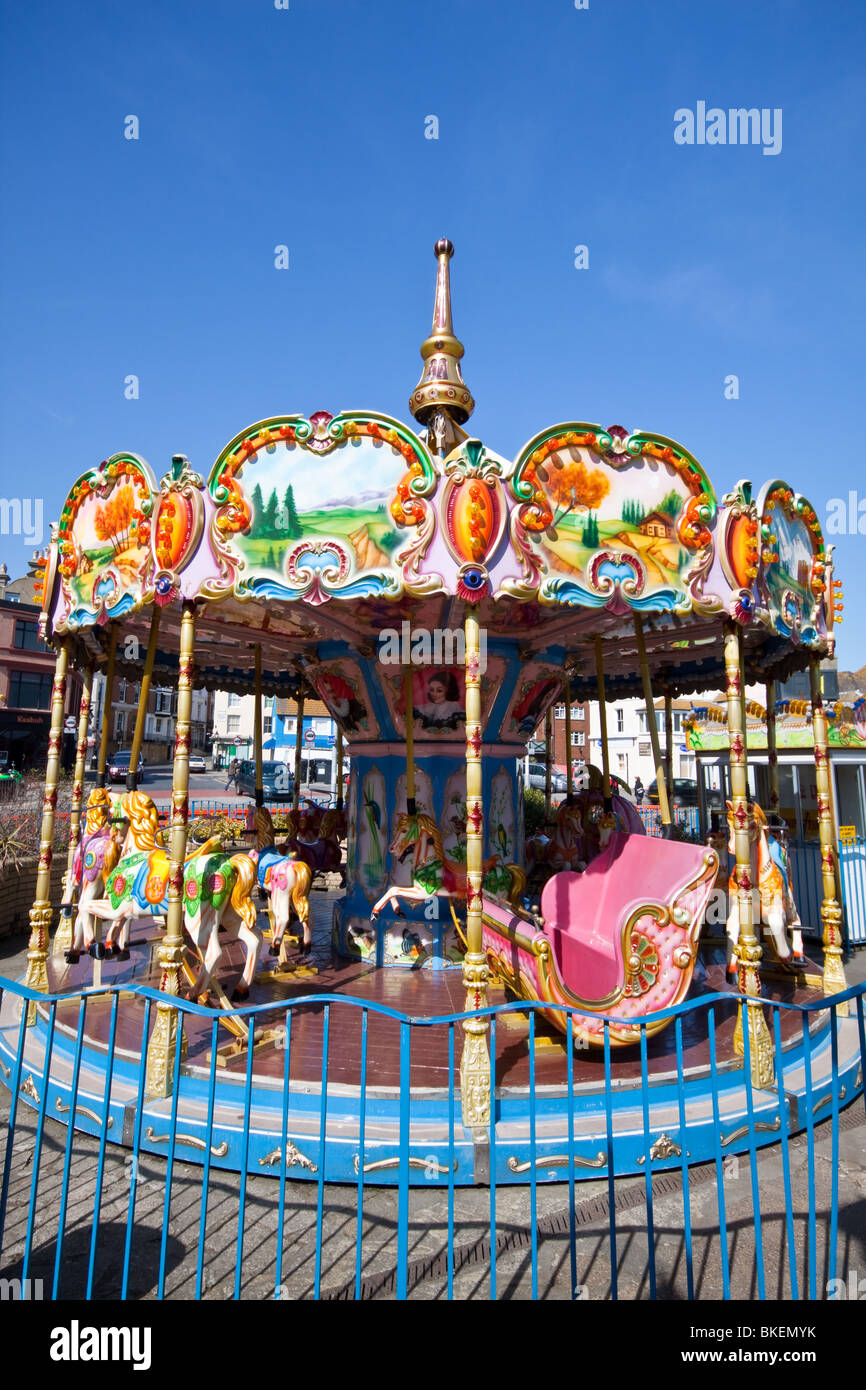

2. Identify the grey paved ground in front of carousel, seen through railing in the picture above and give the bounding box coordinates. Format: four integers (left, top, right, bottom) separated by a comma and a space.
0, 922, 866, 1300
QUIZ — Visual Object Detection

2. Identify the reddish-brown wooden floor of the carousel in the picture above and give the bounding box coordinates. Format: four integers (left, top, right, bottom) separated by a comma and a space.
42, 894, 816, 1088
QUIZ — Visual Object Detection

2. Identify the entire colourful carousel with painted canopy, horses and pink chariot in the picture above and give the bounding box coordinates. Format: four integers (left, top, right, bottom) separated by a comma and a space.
0, 240, 862, 1183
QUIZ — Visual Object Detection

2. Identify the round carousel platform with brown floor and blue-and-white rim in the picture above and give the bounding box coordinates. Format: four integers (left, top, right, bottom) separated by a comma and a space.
0, 894, 862, 1186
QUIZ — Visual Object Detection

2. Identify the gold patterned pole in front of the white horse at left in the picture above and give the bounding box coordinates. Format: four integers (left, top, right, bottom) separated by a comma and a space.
145, 599, 196, 1098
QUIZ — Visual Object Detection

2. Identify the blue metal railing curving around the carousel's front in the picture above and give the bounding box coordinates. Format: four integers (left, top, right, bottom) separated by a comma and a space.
0, 980, 866, 1300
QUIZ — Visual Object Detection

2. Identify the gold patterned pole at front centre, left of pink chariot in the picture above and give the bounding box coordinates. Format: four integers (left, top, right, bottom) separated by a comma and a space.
460, 605, 491, 1129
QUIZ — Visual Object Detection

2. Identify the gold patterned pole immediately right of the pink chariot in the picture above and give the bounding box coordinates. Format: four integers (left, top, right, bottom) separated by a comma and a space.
724, 623, 774, 1087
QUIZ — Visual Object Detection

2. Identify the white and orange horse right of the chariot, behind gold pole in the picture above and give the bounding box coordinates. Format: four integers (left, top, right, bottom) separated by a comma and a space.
726, 801, 803, 974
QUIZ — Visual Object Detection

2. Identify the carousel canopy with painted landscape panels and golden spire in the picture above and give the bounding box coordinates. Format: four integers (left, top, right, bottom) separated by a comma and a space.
35, 242, 838, 737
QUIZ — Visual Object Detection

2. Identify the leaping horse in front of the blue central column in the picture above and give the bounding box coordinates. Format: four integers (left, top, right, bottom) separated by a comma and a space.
370, 812, 525, 919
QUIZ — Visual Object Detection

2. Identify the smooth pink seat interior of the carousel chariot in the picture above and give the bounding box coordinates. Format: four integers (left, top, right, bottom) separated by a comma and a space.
541, 831, 706, 1001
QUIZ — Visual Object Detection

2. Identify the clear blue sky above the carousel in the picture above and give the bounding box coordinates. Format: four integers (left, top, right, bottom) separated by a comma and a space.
0, 0, 866, 667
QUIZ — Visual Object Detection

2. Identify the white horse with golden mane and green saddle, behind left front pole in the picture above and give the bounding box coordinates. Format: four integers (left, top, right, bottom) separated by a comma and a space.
90, 791, 261, 1002
